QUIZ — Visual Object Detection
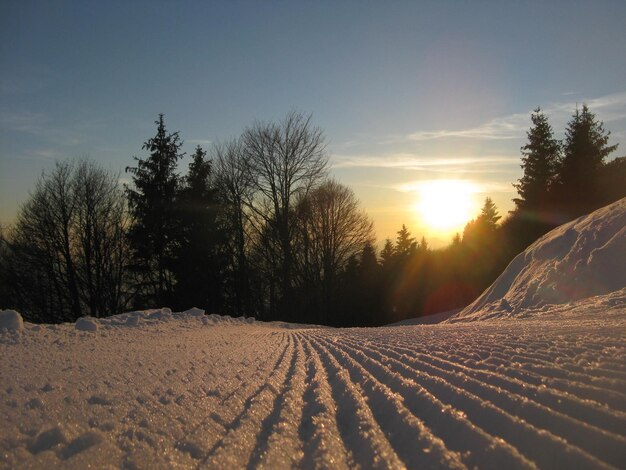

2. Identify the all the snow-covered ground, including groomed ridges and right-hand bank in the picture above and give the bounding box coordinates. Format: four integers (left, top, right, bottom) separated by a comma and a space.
0, 201, 626, 469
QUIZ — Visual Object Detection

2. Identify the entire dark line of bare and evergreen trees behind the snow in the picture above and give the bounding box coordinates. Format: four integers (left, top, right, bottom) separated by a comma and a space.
0, 105, 626, 326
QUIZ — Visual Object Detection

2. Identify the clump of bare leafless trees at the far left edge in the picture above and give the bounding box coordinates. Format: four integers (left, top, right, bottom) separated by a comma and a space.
3, 160, 128, 322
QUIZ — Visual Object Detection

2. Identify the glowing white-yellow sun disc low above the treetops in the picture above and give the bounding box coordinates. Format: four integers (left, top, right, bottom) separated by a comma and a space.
416, 180, 477, 232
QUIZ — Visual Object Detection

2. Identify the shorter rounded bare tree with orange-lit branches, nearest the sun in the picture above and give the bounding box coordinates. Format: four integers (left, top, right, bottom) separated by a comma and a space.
297, 180, 374, 323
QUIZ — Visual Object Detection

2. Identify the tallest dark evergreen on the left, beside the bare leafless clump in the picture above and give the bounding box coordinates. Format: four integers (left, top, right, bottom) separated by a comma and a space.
126, 114, 184, 306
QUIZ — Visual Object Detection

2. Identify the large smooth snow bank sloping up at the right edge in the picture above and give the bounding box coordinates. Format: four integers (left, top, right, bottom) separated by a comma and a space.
449, 198, 626, 322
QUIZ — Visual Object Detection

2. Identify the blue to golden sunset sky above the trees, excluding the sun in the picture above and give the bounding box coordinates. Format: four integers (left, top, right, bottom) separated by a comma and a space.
0, 0, 626, 246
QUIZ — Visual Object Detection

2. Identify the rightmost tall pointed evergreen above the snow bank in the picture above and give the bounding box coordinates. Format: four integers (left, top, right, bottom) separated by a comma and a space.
559, 104, 617, 217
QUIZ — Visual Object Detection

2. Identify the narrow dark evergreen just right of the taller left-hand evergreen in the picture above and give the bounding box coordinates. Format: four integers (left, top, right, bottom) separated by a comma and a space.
173, 146, 226, 312
